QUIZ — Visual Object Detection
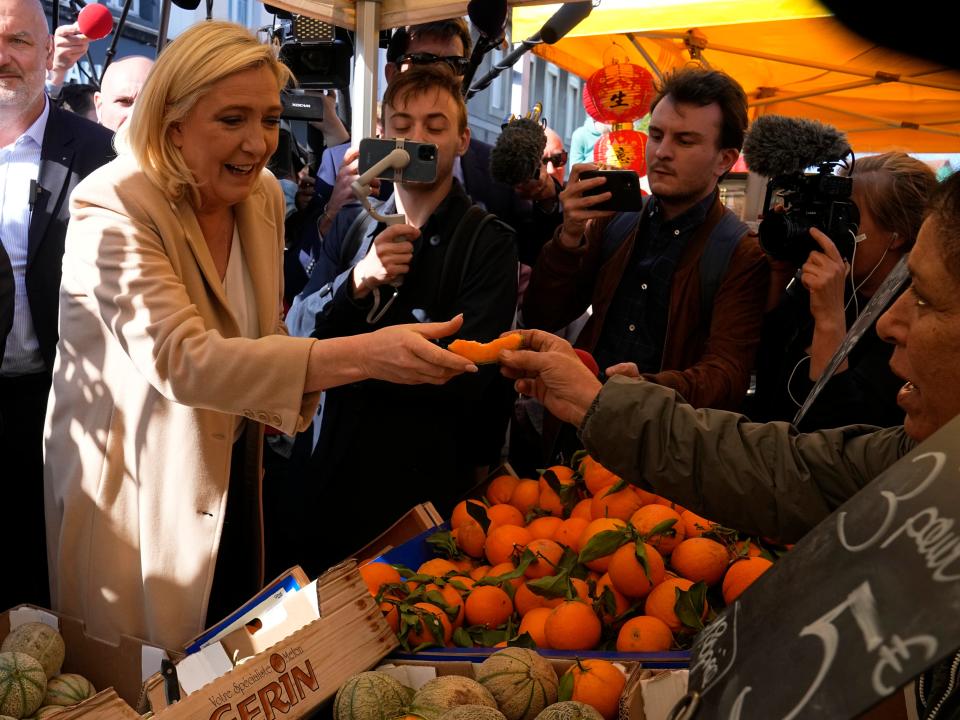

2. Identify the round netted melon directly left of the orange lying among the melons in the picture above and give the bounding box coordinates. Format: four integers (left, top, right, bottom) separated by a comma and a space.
477, 647, 558, 720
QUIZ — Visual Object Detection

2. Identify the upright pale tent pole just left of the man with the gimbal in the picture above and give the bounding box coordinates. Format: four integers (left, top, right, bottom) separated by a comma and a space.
350, 0, 382, 147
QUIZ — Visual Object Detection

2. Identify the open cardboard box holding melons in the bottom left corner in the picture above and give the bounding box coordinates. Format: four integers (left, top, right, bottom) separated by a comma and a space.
0, 605, 171, 720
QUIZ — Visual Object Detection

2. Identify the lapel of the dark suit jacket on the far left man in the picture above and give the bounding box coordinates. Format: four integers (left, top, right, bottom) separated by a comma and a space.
27, 105, 74, 266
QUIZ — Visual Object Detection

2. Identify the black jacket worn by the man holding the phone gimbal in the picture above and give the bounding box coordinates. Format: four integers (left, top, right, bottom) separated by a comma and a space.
301, 181, 517, 567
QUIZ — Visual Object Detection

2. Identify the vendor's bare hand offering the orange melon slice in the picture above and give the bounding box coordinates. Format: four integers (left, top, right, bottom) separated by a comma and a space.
500, 330, 602, 426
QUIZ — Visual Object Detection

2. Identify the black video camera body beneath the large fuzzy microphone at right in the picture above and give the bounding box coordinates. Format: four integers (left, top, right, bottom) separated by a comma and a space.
759, 162, 860, 267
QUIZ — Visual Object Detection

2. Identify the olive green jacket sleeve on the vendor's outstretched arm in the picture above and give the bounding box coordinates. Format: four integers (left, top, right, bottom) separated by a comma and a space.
581, 377, 915, 542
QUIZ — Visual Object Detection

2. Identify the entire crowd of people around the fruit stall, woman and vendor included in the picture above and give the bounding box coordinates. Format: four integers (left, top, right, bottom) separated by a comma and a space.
0, 0, 960, 716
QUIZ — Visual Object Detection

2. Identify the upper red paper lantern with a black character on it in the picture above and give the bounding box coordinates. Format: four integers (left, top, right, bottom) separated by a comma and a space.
583, 63, 656, 125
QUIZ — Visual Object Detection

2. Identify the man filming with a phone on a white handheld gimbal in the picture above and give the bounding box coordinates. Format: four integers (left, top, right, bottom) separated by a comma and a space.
284, 64, 517, 571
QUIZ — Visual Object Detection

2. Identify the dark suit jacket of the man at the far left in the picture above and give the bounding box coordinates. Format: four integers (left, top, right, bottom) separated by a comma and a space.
26, 103, 116, 370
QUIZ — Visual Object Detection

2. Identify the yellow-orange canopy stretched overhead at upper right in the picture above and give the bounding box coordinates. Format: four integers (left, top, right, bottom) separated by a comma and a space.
513, 0, 960, 152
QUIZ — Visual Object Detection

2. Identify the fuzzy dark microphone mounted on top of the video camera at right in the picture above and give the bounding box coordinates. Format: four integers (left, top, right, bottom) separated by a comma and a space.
743, 115, 850, 177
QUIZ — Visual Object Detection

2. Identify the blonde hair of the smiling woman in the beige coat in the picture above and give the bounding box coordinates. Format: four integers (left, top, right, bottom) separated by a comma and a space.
122, 20, 293, 206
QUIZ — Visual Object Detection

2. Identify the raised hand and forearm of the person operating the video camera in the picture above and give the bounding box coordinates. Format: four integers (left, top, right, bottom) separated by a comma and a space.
800, 228, 850, 380
